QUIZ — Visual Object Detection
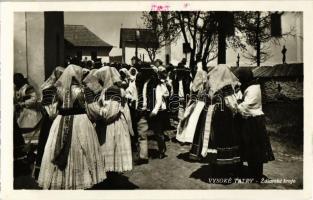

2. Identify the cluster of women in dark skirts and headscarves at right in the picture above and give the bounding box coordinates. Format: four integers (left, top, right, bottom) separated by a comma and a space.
176, 65, 274, 181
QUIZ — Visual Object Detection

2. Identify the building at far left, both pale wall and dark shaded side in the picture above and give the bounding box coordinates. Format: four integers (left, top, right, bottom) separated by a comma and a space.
14, 12, 64, 93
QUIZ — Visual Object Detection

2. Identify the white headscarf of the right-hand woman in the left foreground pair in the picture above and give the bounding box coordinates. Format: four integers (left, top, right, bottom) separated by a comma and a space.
95, 66, 121, 89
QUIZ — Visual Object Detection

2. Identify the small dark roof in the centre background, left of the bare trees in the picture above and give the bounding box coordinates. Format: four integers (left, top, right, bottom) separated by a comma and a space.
120, 28, 159, 48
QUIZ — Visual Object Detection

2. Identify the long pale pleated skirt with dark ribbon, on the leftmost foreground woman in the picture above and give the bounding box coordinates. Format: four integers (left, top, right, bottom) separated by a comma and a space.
38, 114, 106, 189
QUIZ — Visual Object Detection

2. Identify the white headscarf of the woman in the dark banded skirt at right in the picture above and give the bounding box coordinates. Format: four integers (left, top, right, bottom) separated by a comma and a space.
207, 64, 240, 95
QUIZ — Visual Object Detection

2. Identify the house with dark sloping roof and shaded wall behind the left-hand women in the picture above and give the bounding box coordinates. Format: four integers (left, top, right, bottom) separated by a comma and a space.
64, 25, 113, 62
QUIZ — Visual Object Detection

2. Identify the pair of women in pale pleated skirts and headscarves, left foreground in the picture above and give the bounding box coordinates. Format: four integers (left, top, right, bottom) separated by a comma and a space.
23, 64, 133, 189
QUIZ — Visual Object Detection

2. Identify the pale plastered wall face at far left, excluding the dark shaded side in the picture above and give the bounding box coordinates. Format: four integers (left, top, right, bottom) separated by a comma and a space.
14, 12, 45, 92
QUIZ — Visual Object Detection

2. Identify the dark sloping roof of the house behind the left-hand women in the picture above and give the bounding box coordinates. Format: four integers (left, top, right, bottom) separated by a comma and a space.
64, 24, 113, 48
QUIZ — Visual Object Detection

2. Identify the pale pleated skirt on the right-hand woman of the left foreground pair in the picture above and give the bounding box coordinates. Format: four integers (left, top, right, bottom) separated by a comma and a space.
101, 115, 133, 172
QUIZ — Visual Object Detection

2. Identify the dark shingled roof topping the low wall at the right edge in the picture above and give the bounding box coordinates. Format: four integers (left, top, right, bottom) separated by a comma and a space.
253, 63, 303, 78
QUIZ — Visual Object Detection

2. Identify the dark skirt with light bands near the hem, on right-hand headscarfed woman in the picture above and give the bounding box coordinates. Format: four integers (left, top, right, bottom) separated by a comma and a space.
190, 105, 240, 165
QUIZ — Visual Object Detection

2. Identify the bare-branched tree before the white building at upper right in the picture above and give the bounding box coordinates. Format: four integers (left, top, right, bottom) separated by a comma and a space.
234, 11, 292, 66
